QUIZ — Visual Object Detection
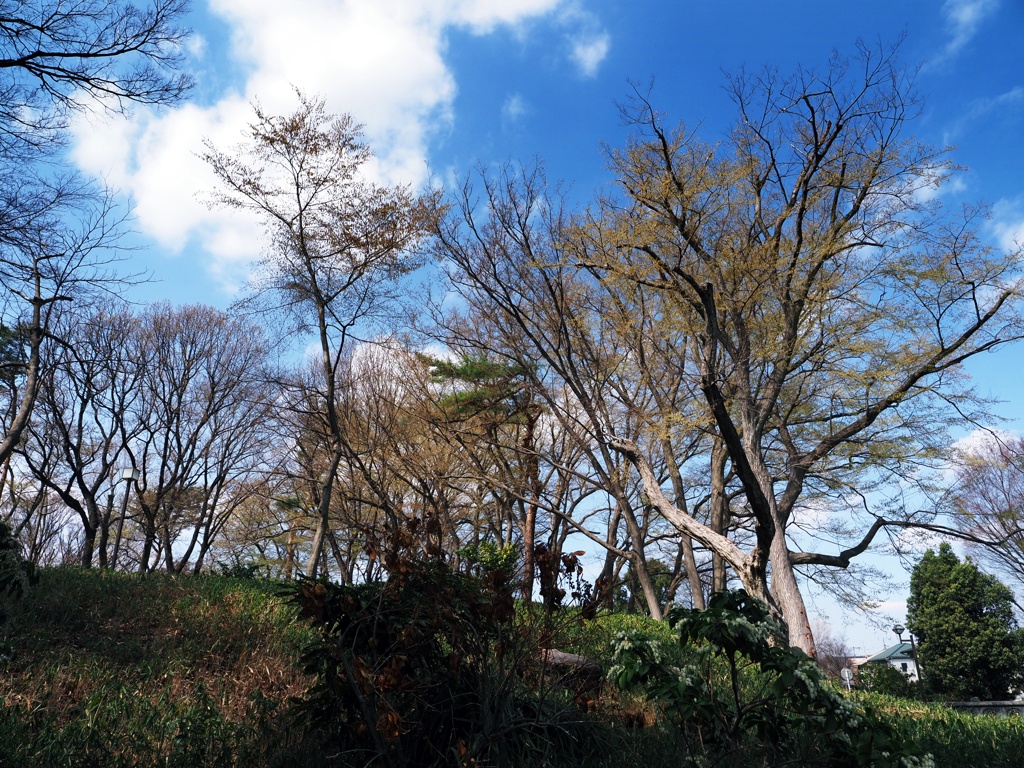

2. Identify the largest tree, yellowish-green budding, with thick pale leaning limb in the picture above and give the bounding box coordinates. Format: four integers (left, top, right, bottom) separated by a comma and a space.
574, 47, 1021, 652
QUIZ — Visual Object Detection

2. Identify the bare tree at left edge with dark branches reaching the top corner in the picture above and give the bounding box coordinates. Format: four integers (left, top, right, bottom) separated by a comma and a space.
0, 0, 189, 466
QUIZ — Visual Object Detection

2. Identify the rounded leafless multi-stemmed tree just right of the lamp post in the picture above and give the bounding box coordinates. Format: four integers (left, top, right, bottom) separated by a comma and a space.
128, 304, 276, 572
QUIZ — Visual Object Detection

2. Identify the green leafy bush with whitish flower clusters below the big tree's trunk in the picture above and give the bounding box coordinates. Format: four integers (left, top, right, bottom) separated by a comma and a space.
609, 592, 931, 768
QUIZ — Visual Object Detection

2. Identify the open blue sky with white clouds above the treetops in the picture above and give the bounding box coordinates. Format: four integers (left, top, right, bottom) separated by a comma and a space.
74, 0, 1024, 645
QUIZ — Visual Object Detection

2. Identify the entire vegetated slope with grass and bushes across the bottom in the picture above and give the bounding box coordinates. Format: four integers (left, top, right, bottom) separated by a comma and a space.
6, 568, 1024, 768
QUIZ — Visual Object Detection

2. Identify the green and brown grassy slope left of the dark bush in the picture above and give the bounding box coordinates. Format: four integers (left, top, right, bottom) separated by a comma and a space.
0, 568, 311, 766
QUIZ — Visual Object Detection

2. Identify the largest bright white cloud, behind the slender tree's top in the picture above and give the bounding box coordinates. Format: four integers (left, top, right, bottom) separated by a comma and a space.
75, 0, 581, 292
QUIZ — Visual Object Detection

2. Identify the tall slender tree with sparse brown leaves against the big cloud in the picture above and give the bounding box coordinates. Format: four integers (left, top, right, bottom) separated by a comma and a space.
203, 94, 433, 574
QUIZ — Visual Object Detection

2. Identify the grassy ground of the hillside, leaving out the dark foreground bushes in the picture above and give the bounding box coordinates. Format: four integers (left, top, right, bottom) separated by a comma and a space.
0, 568, 1024, 768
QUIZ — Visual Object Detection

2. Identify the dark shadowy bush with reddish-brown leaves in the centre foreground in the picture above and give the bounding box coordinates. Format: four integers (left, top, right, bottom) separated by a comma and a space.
284, 559, 607, 768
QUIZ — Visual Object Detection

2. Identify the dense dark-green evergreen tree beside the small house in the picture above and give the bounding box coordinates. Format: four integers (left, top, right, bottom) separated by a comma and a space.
907, 544, 1024, 699
